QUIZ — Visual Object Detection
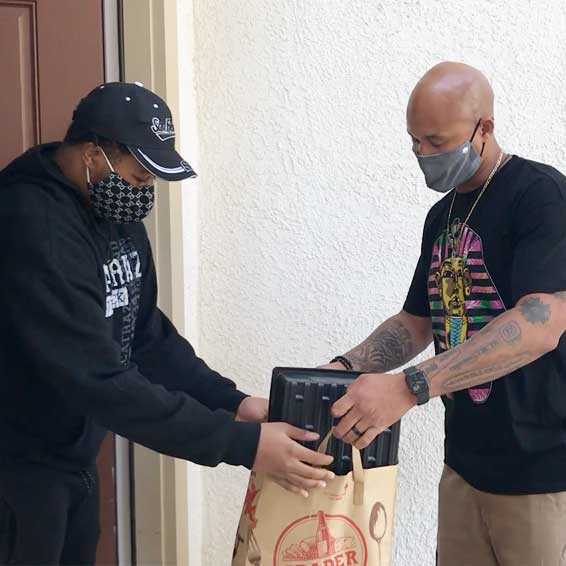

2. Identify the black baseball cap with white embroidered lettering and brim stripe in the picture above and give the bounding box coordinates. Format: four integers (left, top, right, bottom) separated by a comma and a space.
73, 83, 196, 181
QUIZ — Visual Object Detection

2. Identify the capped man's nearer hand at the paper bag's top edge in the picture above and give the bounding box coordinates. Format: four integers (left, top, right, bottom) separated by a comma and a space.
253, 423, 334, 497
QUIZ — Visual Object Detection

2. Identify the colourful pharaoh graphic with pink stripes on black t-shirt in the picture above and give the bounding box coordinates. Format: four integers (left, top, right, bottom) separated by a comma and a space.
428, 219, 505, 404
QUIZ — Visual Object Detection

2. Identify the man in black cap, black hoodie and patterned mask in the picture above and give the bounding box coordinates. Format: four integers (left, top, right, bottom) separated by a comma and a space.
0, 83, 332, 564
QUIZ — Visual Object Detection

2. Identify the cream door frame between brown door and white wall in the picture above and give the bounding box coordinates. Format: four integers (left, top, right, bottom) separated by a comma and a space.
117, 0, 196, 566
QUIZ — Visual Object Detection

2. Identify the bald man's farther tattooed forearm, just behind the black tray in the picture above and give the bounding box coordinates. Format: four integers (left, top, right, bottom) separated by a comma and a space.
346, 318, 416, 373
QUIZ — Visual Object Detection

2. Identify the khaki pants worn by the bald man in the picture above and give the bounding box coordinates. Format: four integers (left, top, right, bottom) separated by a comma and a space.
438, 466, 566, 566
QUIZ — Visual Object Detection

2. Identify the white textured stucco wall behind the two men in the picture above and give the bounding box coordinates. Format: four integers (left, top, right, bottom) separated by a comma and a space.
187, 0, 566, 566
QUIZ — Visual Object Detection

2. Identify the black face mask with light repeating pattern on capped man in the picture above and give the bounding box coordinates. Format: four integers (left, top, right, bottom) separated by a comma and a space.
86, 148, 155, 224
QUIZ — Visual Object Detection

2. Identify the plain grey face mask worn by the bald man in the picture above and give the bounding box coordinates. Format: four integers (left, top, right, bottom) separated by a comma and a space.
417, 120, 485, 193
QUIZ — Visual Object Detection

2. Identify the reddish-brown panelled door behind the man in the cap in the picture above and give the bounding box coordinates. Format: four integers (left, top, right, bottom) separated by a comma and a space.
0, 0, 117, 565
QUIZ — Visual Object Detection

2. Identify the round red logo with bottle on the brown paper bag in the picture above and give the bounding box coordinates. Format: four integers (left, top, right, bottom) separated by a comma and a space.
273, 511, 367, 566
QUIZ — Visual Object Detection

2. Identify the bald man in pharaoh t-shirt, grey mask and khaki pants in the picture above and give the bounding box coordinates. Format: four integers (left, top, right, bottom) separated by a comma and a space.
327, 63, 566, 566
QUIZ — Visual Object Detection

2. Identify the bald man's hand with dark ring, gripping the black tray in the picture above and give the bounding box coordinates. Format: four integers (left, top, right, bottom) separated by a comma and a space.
332, 373, 416, 450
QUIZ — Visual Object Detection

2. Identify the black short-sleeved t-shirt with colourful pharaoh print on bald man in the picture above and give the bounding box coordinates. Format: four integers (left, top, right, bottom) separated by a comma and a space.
404, 157, 566, 494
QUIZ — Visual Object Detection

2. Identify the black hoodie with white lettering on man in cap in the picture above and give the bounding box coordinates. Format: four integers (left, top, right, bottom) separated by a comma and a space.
0, 144, 260, 469
